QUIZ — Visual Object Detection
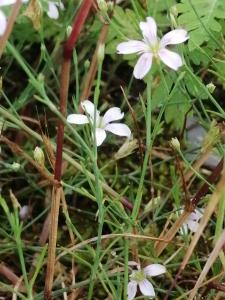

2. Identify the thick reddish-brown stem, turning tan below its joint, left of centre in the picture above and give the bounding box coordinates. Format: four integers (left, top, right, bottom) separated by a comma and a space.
44, 0, 92, 300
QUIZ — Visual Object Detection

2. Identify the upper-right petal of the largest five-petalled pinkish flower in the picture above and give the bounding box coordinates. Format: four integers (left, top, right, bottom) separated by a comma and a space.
160, 29, 189, 47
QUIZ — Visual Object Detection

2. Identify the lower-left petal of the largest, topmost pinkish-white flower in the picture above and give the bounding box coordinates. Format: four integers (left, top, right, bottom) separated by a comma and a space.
133, 53, 153, 79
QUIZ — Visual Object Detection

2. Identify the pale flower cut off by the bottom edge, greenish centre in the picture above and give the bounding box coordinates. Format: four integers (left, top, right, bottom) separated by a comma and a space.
127, 264, 166, 300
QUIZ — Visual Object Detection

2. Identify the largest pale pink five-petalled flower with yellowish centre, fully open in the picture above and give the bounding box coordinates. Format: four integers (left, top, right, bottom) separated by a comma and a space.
117, 17, 188, 79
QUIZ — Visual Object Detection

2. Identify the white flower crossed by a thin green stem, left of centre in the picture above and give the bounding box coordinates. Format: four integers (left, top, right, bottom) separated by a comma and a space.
67, 100, 131, 146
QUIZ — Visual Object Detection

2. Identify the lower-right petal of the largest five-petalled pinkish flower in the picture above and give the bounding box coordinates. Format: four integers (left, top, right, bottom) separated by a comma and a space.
158, 48, 183, 71
